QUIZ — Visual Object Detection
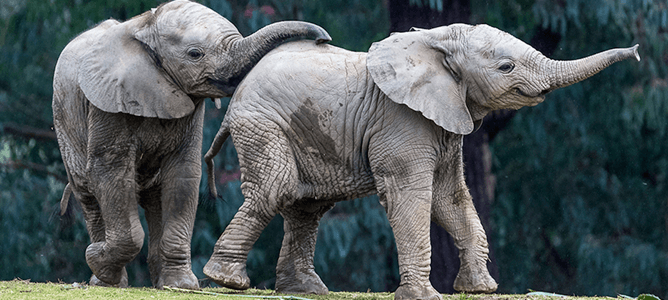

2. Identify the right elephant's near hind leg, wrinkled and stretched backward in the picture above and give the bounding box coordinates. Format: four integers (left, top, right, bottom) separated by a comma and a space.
204, 120, 297, 289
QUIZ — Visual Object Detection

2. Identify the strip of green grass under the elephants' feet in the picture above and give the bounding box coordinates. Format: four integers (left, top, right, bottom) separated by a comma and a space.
0, 280, 652, 300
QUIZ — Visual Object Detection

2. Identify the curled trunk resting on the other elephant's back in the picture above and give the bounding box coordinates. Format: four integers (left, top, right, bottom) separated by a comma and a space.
217, 21, 332, 95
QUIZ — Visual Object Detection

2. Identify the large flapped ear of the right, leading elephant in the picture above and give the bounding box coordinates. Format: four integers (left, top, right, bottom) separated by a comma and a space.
367, 30, 474, 134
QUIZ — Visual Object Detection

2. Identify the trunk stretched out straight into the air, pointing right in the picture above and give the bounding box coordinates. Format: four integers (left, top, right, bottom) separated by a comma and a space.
544, 45, 640, 90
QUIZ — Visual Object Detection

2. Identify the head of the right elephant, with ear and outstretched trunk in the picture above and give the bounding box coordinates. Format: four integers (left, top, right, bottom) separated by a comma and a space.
367, 24, 640, 134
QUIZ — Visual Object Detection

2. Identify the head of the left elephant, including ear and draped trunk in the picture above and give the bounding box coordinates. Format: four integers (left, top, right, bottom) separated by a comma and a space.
78, 0, 331, 119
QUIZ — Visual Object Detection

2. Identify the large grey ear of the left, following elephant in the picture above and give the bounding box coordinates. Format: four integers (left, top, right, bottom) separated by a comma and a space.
78, 17, 195, 119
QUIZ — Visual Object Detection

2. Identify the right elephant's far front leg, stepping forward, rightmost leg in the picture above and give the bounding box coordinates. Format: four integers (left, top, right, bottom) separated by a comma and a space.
432, 140, 498, 293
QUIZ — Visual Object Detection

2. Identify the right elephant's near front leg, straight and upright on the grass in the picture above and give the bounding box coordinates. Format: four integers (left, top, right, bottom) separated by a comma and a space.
379, 174, 442, 299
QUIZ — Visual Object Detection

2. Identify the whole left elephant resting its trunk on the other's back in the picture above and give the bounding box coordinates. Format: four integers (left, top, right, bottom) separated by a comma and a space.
53, 0, 330, 288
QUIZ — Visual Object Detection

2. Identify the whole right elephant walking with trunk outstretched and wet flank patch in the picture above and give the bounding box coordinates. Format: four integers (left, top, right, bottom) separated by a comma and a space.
204, 24, 639, 299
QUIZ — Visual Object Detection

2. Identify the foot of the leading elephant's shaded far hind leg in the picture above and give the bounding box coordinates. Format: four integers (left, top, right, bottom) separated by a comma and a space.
276, 269, 329, 295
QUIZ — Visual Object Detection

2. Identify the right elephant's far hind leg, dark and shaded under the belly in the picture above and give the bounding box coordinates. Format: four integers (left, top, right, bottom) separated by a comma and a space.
276, 199, 334, 295
